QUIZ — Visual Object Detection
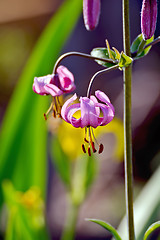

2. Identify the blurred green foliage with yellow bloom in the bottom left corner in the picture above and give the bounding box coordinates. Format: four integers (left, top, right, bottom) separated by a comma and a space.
2, 181, 48, 240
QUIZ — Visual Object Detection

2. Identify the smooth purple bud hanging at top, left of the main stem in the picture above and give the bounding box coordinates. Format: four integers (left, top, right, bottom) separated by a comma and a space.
83, 0, 101, 31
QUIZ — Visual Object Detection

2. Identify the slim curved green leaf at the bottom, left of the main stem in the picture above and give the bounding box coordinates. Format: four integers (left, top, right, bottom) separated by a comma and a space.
86, 218, 122, 240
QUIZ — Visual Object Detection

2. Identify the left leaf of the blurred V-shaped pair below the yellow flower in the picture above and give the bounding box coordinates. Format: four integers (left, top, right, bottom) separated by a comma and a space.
51, 137, 71, 188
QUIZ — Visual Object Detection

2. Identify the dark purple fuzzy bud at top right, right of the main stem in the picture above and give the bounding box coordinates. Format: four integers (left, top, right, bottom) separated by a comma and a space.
141, 0, 157, 40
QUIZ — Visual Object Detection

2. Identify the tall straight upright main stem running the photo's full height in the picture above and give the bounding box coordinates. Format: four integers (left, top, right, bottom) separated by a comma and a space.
122, 0, 134, 240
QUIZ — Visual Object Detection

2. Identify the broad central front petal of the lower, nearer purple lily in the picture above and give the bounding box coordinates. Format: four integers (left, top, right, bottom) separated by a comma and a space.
80, 97, 98, 128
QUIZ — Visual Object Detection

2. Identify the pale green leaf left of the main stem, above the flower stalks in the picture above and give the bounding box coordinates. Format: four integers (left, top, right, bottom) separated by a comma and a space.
91, 48, 117, 67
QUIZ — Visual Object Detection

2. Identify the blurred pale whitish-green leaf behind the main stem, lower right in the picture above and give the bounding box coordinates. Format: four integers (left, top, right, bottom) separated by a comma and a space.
118, 166, 160, 240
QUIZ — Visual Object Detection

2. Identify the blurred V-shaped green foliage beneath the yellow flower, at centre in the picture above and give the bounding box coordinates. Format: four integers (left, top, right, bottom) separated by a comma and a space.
51, 137, 97, 206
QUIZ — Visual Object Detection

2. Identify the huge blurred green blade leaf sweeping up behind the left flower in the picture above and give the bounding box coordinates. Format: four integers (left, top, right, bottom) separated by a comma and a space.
0, 0, 82, 203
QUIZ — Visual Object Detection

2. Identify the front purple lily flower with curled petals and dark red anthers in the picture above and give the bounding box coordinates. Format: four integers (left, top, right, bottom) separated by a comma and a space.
61, 90, 115, 156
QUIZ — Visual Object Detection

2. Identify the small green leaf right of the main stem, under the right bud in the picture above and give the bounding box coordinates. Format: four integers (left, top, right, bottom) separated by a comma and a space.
131, 34, 154, 59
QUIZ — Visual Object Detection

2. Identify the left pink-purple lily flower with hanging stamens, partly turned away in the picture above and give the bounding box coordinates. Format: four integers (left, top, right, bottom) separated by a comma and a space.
33, 66, 75, 119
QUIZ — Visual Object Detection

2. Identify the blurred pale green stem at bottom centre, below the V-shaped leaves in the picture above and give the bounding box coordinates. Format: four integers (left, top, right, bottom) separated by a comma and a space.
61, 201, 79, 240
